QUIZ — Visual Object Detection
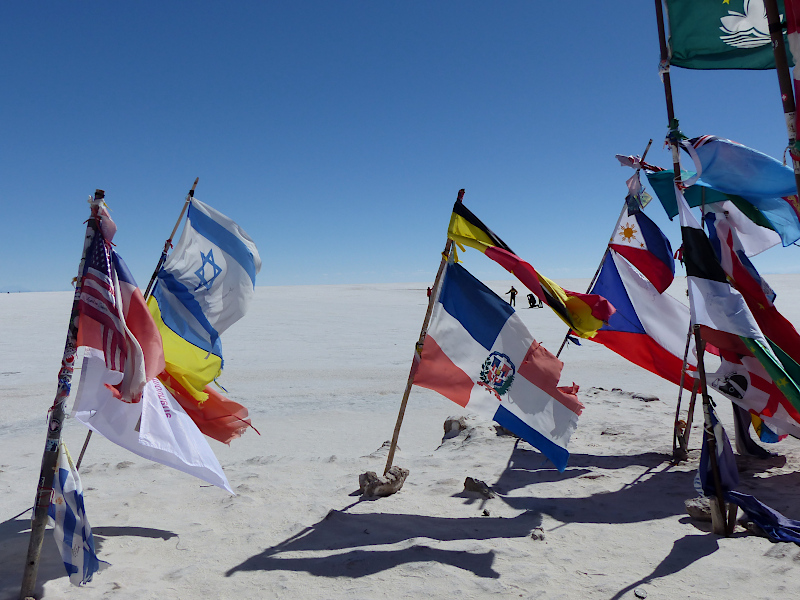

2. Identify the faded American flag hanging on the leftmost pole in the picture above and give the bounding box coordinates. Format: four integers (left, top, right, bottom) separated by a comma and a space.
79, 229, 128, 371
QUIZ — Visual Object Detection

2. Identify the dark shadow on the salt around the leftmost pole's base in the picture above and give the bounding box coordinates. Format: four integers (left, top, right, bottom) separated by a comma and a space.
0, 518, 176, 600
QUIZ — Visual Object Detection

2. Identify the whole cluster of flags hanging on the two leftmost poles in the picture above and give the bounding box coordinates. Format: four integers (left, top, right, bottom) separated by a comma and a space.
50, 197, 261, 585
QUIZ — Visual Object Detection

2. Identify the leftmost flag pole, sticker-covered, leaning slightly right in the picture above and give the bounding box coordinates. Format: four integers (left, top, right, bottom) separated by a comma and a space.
19, 190, 105, 600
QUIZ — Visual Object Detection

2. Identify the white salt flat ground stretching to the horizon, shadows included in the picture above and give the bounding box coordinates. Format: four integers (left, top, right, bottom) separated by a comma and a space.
0, 275, 800, 600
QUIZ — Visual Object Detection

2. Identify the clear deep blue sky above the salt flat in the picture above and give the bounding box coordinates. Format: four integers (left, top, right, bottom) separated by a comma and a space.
0, 0, 800, 291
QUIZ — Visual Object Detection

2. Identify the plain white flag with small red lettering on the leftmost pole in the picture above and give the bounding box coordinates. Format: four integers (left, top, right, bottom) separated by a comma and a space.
72, 349, 233, 494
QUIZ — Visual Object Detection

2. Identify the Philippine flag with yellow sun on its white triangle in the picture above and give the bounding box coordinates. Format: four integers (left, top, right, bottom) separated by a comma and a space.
611, 212, 675, 294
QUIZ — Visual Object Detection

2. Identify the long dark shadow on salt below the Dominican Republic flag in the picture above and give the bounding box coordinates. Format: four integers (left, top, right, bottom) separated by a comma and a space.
226, 503, 542, 578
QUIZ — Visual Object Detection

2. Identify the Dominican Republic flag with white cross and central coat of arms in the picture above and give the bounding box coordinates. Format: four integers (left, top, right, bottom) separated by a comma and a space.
414, 264, 583, 471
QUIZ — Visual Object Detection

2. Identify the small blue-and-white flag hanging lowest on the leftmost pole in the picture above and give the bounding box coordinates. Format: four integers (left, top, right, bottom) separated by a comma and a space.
47, 440, 108, 585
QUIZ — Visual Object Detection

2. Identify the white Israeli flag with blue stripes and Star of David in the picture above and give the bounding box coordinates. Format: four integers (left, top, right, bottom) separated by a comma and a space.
153, 198, 261, 357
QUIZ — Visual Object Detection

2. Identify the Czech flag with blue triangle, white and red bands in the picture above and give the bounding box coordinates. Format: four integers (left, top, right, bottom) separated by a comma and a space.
591, 247, 697, 389
